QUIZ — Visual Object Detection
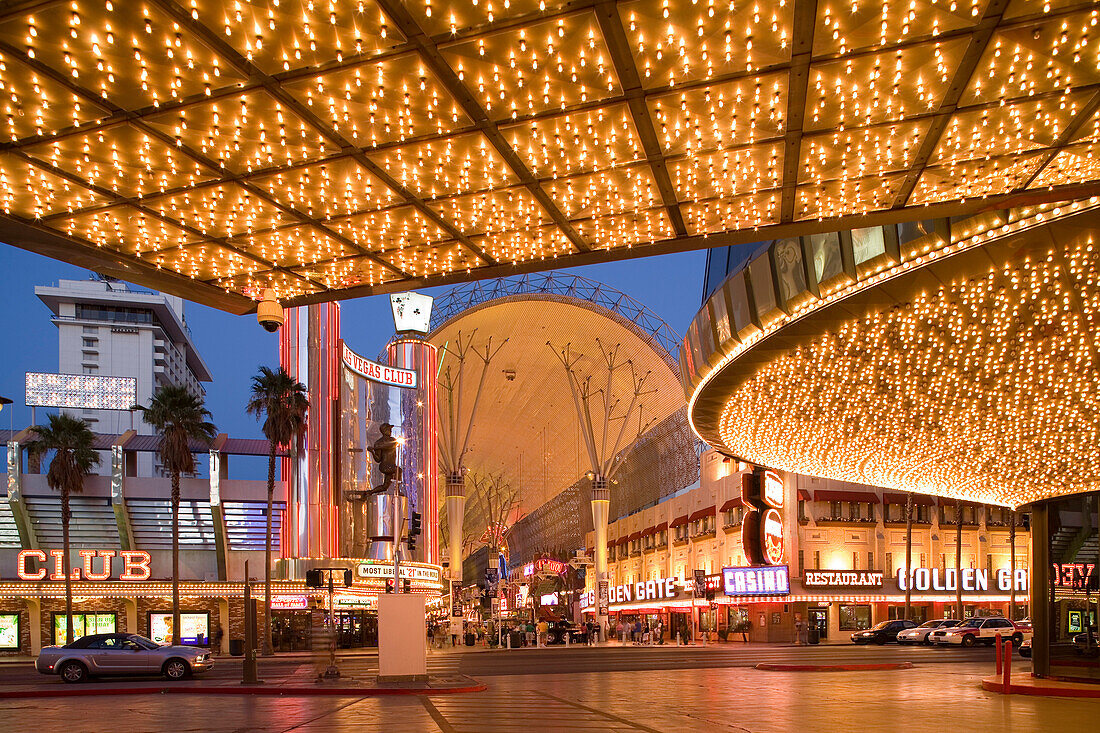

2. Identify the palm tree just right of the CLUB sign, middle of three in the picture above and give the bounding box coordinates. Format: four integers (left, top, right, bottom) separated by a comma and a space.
133, 384, 218, 645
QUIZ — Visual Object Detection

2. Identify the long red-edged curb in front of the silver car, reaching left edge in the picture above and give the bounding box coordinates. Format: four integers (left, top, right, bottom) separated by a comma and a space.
0, 682, 488, 700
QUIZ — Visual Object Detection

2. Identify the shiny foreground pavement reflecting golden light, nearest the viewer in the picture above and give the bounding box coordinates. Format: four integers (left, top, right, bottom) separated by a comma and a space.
0, 649, 1100, 733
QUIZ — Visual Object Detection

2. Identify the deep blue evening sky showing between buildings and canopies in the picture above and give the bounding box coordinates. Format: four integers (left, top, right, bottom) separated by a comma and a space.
0, 244, 706, 437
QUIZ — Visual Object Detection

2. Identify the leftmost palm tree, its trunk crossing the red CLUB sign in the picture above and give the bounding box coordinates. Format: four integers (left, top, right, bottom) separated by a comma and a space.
31, 414, 99, 644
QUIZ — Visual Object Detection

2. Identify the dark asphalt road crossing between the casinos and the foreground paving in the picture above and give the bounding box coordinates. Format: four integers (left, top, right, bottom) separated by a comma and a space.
0, 644, 994, 686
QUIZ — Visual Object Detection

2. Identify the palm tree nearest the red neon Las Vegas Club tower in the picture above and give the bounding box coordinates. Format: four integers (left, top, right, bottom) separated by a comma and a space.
245, 367, 309, 655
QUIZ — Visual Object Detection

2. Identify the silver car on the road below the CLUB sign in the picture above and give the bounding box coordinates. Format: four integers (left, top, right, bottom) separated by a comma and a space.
34, 634, 213, 682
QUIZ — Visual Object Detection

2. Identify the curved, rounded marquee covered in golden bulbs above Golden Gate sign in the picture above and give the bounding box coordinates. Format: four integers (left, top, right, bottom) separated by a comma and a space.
682, 198, 1100, 506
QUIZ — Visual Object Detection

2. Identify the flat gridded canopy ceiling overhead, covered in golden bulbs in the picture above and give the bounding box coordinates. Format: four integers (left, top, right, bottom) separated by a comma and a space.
0, 0, 1100, 311
